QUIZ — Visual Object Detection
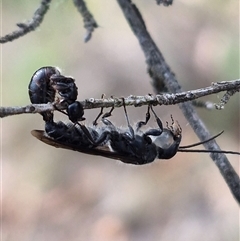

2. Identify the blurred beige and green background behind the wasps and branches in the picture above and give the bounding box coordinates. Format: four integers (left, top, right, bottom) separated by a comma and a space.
1, 0, 240, 241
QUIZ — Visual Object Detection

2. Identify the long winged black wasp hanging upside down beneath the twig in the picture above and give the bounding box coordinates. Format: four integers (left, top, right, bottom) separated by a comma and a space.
31, 100, 240, 165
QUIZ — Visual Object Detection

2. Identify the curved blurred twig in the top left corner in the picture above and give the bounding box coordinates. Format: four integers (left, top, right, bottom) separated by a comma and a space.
0, 0, 51, 44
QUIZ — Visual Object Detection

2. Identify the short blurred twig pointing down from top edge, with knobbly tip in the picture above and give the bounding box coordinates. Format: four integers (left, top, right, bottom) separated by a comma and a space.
73, 0, 98, 43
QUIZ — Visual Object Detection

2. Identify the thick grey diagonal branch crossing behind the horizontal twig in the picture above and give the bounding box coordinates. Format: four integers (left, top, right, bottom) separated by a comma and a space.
117, 0, 240, 203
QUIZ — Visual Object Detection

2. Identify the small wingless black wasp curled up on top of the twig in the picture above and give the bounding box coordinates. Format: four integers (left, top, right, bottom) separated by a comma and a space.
28, 66, 84, 123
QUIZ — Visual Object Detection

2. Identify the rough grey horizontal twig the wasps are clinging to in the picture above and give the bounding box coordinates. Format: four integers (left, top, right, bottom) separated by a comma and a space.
0, 80, 240, 118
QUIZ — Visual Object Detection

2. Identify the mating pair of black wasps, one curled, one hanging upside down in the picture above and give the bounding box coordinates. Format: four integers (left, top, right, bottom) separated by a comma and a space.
29, 67, 240, 165
